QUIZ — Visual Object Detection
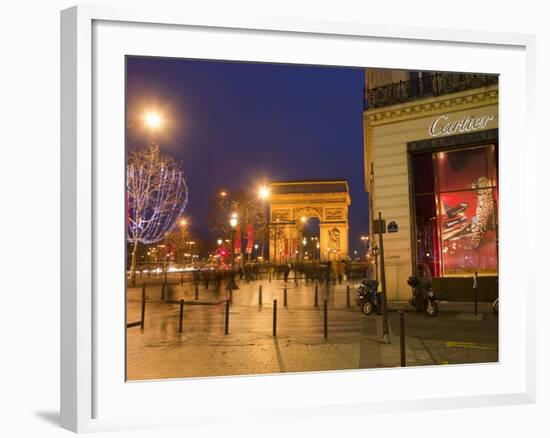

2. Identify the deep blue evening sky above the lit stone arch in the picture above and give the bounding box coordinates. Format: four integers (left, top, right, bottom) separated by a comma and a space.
127, 57, 368, 254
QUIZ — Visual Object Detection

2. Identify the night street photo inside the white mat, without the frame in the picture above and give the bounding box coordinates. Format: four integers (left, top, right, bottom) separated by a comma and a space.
125, 56, 499, 381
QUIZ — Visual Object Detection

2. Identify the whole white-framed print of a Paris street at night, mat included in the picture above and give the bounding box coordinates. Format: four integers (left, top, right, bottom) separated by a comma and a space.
61, 7, 536, 431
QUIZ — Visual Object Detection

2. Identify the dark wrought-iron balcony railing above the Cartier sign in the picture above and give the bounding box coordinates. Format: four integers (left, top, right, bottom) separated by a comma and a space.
364, 73, 498, 110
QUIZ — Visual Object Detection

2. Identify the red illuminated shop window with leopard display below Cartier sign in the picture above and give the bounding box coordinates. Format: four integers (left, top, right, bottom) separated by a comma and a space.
412, 145, 498, 277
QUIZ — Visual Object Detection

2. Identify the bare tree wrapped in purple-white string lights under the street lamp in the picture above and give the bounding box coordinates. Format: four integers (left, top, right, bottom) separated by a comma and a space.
126, 143, 188, 284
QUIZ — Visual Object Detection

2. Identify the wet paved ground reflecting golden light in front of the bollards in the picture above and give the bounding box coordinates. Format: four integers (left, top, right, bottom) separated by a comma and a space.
127, 280, 498, 380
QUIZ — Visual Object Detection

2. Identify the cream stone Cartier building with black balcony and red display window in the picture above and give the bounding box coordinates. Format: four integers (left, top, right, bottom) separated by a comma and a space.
364, 69, 498, 300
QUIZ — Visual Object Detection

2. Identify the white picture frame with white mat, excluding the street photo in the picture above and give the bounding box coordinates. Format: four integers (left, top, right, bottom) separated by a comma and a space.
61, 6, 537, 432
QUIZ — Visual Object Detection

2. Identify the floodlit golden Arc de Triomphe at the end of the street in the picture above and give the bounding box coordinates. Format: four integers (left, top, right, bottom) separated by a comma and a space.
269, 180, 351, 263
